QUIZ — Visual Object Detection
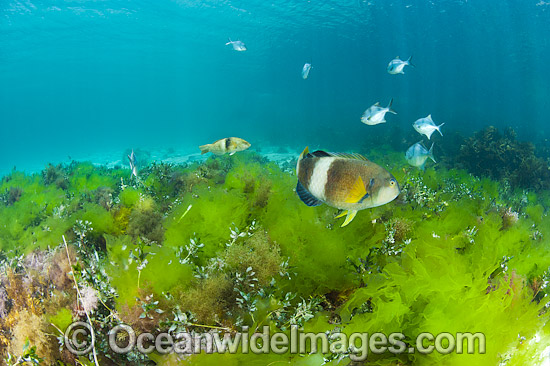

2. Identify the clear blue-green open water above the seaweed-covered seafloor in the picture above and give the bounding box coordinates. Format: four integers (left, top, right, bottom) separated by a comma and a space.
0, 0, 550, 173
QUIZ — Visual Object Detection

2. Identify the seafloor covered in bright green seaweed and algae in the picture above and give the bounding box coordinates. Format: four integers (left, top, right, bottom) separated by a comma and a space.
0, 130, 550, 366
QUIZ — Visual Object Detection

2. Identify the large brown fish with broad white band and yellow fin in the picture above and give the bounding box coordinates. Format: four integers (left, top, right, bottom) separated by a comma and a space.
296, 147, 399, 227
